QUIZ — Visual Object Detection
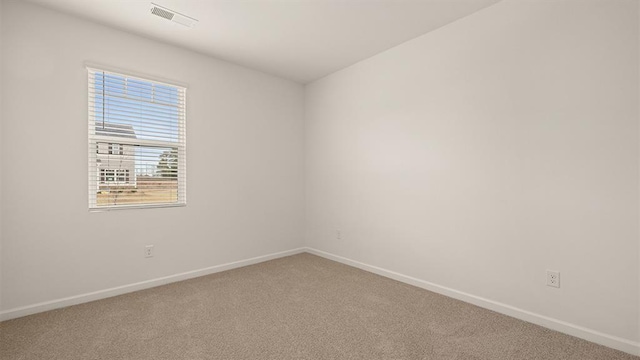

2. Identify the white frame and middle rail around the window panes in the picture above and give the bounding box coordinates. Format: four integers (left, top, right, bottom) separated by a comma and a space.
86, 63, 187, 211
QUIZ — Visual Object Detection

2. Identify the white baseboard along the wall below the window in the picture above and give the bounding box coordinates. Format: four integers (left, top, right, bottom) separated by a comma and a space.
0, 248, 304, 321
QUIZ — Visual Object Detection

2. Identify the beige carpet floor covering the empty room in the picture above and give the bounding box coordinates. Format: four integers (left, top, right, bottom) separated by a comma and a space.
0, 254, 639, 360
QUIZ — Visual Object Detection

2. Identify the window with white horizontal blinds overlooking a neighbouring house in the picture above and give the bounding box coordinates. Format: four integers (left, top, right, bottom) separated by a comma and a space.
88, 68, 186, 209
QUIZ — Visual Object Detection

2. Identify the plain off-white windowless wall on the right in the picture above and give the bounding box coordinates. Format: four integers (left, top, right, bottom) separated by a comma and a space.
305, 1, 639, 342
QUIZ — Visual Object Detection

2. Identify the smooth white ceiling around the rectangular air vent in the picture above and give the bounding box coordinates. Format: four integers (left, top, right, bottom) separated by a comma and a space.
29, 0, 499, 84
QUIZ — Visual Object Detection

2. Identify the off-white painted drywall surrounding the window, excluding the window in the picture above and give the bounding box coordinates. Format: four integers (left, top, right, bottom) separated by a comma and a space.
2, 1, 304, 311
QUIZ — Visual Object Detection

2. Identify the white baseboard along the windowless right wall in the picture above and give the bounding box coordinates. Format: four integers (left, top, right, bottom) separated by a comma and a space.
305, 247, 640, 355
